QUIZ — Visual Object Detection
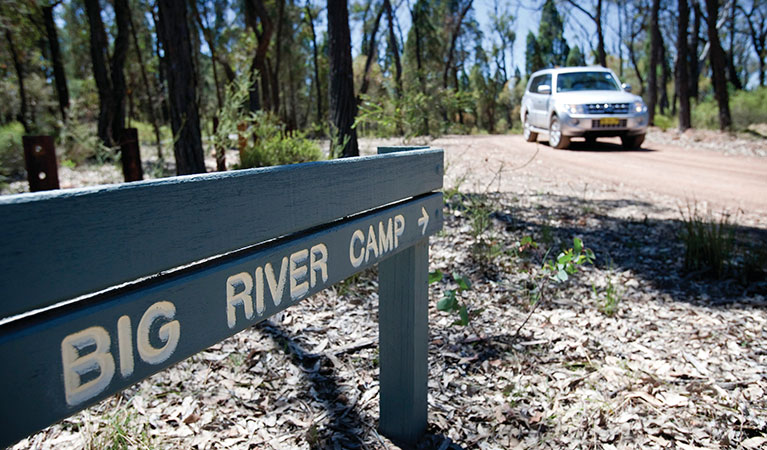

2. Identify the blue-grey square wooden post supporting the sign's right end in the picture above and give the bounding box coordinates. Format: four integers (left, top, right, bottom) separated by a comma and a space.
378, 147, 429, 447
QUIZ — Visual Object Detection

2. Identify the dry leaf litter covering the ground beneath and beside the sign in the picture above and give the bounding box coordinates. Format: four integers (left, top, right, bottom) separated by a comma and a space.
7, 135, 767, 449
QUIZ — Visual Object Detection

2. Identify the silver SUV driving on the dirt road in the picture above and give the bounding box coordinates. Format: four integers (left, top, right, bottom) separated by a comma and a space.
521, 67, 648, 149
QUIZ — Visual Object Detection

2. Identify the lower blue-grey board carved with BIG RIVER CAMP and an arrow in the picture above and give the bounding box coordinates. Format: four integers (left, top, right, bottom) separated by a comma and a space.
0, 193, 443, 446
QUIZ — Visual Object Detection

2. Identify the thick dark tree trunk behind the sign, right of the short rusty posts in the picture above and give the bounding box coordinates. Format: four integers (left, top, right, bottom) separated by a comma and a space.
158, 0, 205, 175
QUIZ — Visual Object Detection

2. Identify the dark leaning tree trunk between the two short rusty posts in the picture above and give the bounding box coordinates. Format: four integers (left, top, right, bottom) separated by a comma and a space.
84, 0, 115, 147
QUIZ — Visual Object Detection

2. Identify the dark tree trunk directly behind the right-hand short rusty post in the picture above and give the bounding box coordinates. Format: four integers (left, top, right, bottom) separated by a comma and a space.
110, 0, 130, 144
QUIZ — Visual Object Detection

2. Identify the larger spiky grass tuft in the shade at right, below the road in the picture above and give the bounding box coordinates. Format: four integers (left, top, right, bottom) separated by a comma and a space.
680, 204, 735, 278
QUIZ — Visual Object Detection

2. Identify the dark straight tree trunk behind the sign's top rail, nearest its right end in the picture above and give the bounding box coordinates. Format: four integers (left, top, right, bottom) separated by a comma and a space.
328, 0, 359, 157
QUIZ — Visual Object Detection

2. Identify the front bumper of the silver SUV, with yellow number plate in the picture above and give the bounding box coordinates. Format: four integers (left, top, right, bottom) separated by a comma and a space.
558, 112, 648, 137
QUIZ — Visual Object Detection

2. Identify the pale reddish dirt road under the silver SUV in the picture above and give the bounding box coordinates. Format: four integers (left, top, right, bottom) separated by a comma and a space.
420, 136, 767, 224
